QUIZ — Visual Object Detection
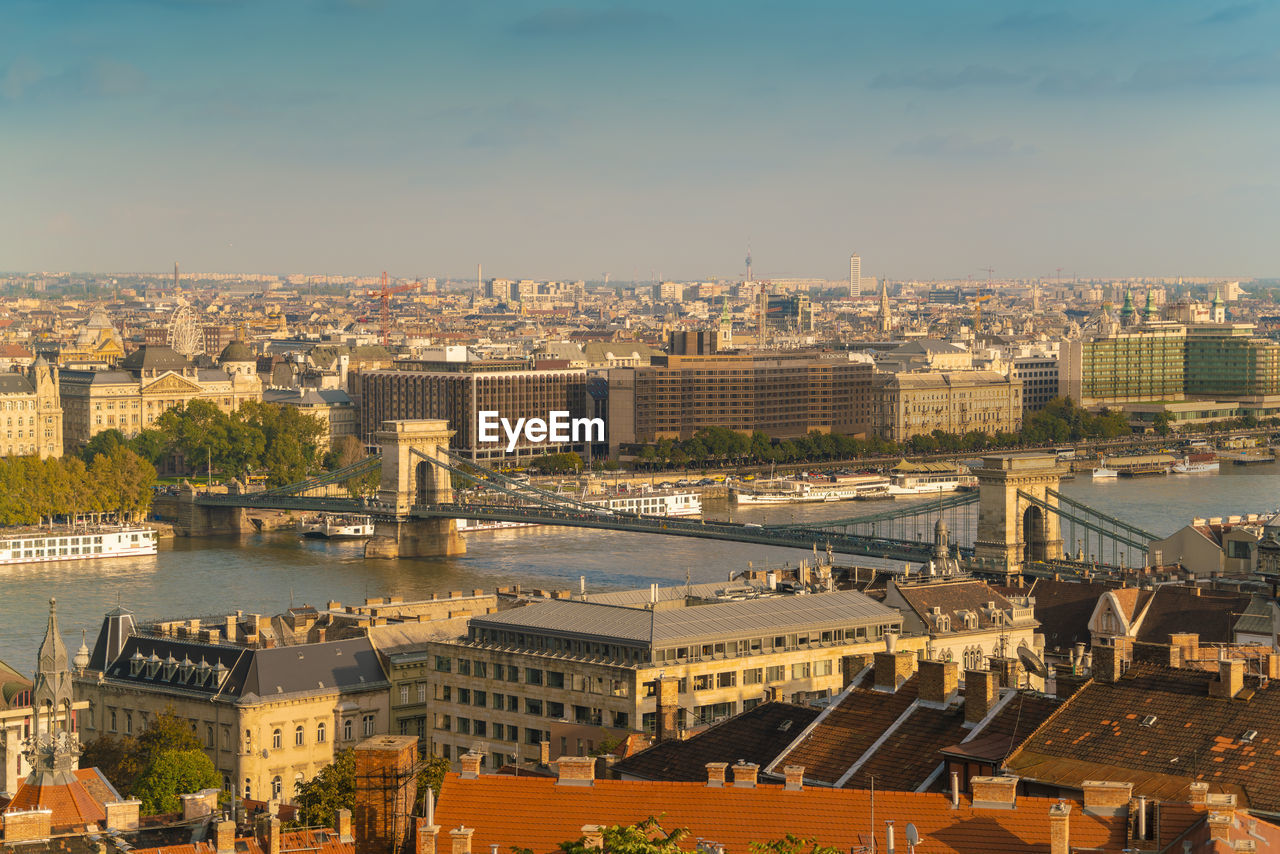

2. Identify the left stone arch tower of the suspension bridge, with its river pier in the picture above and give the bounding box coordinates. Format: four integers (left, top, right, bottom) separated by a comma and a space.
365, 420, 467, 557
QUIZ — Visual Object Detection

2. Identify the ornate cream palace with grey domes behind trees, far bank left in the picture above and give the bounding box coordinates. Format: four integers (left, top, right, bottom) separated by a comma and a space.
59, 346, 262, 448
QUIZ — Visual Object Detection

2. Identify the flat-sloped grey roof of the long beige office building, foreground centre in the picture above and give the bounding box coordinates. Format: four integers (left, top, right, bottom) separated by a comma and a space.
471, 590, 901, 645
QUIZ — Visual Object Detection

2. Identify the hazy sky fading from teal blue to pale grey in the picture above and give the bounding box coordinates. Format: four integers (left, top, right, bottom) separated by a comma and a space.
0, 0, 1280, 279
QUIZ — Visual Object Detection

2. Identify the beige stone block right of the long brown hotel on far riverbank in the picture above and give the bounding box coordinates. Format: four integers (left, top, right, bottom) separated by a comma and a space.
876, 370, 1023, 442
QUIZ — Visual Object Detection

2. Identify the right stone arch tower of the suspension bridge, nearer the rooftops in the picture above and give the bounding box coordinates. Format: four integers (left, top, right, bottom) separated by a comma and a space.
973, 453, 1066, 575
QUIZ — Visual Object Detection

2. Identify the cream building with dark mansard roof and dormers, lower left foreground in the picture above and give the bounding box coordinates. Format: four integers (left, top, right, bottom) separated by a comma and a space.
74, 608, 388, 803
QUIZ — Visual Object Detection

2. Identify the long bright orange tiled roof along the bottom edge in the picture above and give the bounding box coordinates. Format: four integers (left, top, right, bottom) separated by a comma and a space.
435, 773, 1126, 854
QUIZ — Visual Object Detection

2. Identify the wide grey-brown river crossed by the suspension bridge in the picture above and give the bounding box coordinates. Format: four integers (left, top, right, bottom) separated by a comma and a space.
0, 463, 1280, 673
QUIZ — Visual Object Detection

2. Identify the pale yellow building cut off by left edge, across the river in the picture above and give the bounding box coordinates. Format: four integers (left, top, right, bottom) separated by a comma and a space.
0, 357, 63, 460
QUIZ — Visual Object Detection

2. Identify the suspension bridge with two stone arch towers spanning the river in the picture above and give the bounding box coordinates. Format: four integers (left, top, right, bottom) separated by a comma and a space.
177, 420, 1158, 577
